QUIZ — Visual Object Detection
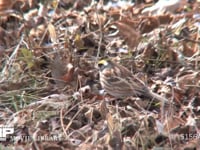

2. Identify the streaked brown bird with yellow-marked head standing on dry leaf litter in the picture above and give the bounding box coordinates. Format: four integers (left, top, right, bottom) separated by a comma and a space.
98, 59, 169, 103
